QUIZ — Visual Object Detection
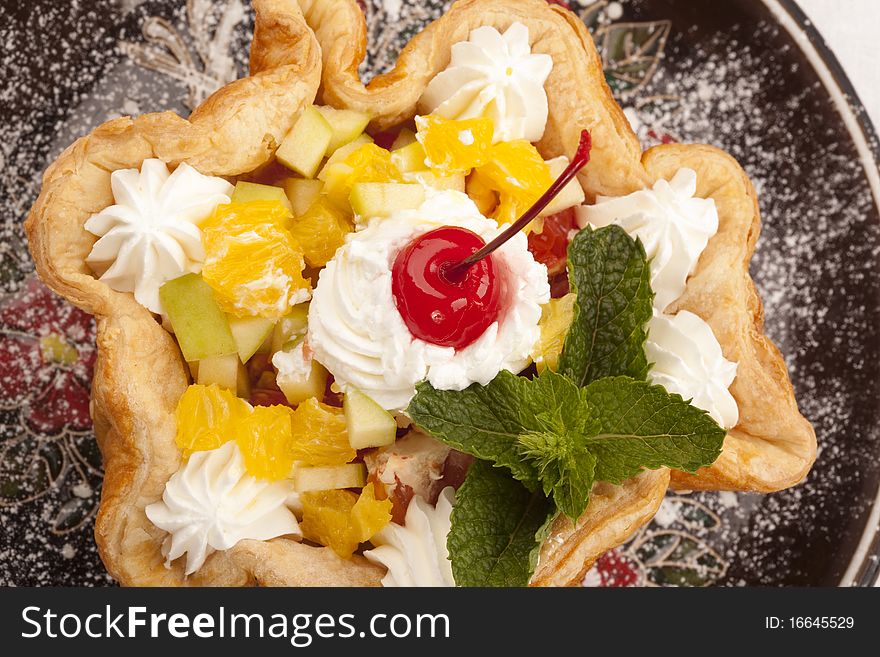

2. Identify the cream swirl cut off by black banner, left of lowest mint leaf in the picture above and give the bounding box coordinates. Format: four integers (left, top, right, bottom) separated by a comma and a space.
364, 486, 455, 587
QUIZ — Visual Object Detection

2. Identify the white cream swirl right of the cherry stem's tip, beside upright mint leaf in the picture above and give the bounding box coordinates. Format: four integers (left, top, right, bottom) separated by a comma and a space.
577, 169, 718, 312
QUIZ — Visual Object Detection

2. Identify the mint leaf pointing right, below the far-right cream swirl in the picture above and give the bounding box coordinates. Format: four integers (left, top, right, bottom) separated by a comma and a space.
584, 377, 727, 484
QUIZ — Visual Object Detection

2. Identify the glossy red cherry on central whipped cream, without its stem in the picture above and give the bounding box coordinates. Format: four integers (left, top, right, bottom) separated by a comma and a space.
391, 226, 503, 349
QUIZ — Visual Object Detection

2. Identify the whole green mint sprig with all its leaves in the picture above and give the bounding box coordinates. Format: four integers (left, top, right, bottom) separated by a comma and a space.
407, 226, 725, 586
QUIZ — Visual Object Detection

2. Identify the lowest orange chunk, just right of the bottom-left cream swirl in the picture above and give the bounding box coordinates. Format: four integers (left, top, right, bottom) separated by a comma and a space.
300, 483, 391, 559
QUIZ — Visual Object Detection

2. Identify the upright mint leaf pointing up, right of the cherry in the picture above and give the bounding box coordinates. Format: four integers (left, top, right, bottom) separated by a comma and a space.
559, 225, 654, 386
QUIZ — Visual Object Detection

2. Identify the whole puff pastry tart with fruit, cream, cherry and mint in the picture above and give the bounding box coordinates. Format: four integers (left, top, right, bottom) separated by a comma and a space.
26, 0, 816, 586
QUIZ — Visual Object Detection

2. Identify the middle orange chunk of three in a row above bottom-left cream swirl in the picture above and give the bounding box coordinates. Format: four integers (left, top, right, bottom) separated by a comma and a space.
236, 406, 294, 481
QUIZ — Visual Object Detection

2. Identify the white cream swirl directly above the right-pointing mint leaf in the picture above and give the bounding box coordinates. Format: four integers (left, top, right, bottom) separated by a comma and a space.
645, 310, 739, 429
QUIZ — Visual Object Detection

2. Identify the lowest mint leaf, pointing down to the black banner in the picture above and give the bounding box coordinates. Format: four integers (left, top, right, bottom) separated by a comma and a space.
447, 460, 552, 586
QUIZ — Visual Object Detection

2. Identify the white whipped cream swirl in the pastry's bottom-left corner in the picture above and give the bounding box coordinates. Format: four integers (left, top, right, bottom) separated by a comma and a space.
145, 440, 302, 575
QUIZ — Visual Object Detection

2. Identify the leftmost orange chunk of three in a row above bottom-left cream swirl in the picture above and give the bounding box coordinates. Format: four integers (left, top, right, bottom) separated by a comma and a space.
175, 384, 250, 457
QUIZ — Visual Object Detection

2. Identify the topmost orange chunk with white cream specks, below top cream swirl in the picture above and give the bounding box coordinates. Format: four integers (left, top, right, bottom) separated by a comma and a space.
416, 116, 494, 176
